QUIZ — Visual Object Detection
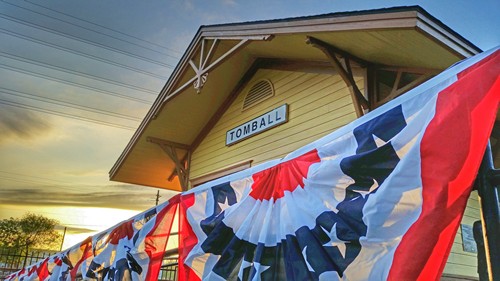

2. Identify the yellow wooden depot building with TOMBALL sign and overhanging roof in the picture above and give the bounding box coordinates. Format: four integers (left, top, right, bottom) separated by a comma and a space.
110, 6, 496, 280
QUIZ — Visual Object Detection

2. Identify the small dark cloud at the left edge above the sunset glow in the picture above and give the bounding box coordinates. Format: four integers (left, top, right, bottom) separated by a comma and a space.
0, 105, 52, 144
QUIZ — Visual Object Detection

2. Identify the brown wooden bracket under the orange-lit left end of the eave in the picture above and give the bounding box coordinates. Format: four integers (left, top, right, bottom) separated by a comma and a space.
147, 137, 192, 191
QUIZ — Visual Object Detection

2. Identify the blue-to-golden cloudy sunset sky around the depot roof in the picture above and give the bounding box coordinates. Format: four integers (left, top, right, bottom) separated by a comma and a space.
0, 0, 500, 248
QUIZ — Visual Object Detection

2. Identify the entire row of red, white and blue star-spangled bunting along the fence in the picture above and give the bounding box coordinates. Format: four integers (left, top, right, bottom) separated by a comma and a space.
7, 48, 500, 281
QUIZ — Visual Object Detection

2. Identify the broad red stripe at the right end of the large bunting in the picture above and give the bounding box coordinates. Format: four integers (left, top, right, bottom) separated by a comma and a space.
388, 51, 500, 280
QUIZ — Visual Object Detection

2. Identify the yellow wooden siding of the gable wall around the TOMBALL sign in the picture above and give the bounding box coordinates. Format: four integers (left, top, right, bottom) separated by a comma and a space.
191, 70, 364, 178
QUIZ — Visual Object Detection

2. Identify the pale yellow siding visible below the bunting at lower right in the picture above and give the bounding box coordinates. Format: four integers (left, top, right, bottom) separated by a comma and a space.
443, 191, 480, 279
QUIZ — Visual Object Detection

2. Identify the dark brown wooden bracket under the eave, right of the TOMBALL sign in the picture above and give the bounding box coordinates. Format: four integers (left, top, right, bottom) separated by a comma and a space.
306, 36, 370, 117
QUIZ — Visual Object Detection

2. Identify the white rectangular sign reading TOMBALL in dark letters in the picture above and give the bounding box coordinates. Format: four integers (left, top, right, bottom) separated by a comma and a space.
226, 104, 288, 145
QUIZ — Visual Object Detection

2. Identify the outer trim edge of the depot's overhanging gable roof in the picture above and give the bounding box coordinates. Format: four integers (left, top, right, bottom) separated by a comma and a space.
109, 6, 481, 184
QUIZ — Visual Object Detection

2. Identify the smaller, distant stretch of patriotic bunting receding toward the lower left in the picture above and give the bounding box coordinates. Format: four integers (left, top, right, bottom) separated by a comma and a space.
5, 196, 179, 281
